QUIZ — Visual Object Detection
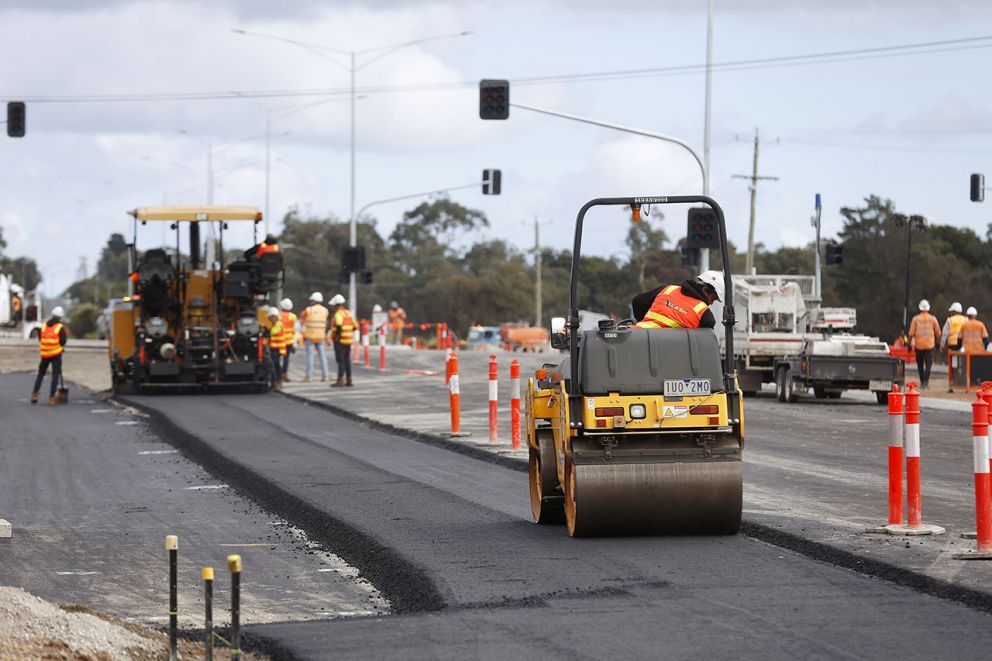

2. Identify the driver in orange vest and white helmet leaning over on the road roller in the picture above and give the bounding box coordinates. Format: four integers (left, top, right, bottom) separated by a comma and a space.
631, 271, 724, 328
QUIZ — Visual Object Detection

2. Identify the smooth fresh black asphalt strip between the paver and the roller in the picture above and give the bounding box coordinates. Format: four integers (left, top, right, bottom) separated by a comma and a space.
120, 395, 992, 659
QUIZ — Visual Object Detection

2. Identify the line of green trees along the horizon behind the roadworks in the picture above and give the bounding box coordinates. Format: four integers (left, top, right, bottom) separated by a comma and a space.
60, 196, 992, 340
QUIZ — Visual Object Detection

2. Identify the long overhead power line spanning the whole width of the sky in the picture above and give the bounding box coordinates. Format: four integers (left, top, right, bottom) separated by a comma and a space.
5, 35, 992, 104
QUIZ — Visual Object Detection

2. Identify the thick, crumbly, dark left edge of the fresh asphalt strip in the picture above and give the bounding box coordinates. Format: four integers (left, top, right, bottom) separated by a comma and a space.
106, 393, 447, 614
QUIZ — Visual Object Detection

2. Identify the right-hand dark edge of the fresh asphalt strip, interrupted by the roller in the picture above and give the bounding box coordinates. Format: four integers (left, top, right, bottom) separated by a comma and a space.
279, 391, 992, 614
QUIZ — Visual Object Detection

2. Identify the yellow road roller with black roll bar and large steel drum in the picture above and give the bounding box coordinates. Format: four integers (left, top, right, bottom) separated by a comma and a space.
526, 196, 744, 537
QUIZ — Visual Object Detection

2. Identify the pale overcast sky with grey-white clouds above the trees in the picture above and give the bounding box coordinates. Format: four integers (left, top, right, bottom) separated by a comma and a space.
0, 0, 992, 294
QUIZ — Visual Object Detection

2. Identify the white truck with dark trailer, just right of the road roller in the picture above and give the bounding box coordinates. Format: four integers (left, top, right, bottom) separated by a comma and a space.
714, 275, 905, 404
